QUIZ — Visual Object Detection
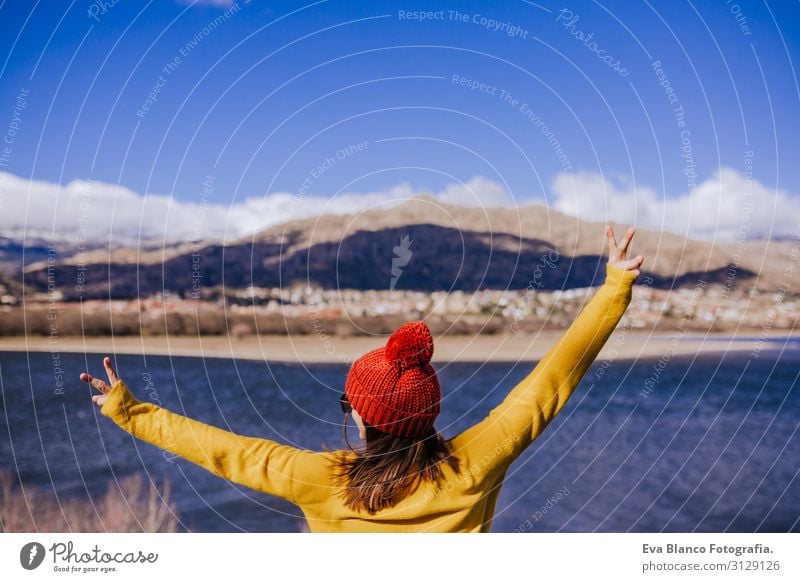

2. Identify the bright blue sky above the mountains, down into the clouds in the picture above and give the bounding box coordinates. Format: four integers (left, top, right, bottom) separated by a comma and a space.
0, 0, 800, 242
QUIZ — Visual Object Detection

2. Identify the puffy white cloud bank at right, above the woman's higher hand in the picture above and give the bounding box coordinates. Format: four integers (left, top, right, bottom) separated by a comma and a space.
553, 167, 800, 242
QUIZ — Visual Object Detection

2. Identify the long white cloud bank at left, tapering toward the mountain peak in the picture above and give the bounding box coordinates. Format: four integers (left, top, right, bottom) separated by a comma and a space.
0, 172, 508, 243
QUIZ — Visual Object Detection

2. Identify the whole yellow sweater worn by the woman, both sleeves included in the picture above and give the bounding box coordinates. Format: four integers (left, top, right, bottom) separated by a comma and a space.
101, 264, 636, 532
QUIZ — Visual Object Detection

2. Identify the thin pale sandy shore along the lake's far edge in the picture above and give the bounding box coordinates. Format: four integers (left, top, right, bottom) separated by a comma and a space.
0, 330, 800, 363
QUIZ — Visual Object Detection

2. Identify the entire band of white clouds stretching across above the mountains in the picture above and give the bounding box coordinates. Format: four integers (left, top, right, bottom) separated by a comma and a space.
0, 168, 800, 243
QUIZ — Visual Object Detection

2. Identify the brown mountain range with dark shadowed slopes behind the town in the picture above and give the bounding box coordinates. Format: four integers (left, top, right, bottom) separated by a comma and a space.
14, 196, 797, 299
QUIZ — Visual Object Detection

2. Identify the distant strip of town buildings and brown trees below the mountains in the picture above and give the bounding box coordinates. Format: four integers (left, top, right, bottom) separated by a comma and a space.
0, 278, 800, 336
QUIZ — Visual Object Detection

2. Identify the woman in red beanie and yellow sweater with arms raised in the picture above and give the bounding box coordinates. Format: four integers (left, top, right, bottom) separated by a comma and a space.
81, 226, 644, 532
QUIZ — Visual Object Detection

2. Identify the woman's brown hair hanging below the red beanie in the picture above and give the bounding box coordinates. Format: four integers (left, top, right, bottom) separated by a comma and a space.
328, 415, 460, 515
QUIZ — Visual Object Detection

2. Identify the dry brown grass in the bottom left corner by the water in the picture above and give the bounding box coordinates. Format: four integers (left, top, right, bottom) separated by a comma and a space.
0, 471, 178, 533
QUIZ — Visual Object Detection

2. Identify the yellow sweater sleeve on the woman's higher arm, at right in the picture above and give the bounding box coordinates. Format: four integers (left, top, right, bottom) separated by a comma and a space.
453, 263, 637, 470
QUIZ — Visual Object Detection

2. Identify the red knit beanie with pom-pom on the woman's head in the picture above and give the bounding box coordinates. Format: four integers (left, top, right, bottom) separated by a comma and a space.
345, 321, 442, 437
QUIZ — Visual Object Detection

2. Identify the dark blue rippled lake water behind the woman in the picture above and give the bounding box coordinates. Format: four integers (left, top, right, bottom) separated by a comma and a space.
0, 350, 800, 532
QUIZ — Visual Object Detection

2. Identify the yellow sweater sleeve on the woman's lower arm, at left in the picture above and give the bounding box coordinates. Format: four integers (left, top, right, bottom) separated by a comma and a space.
100, 380, 304, 501
